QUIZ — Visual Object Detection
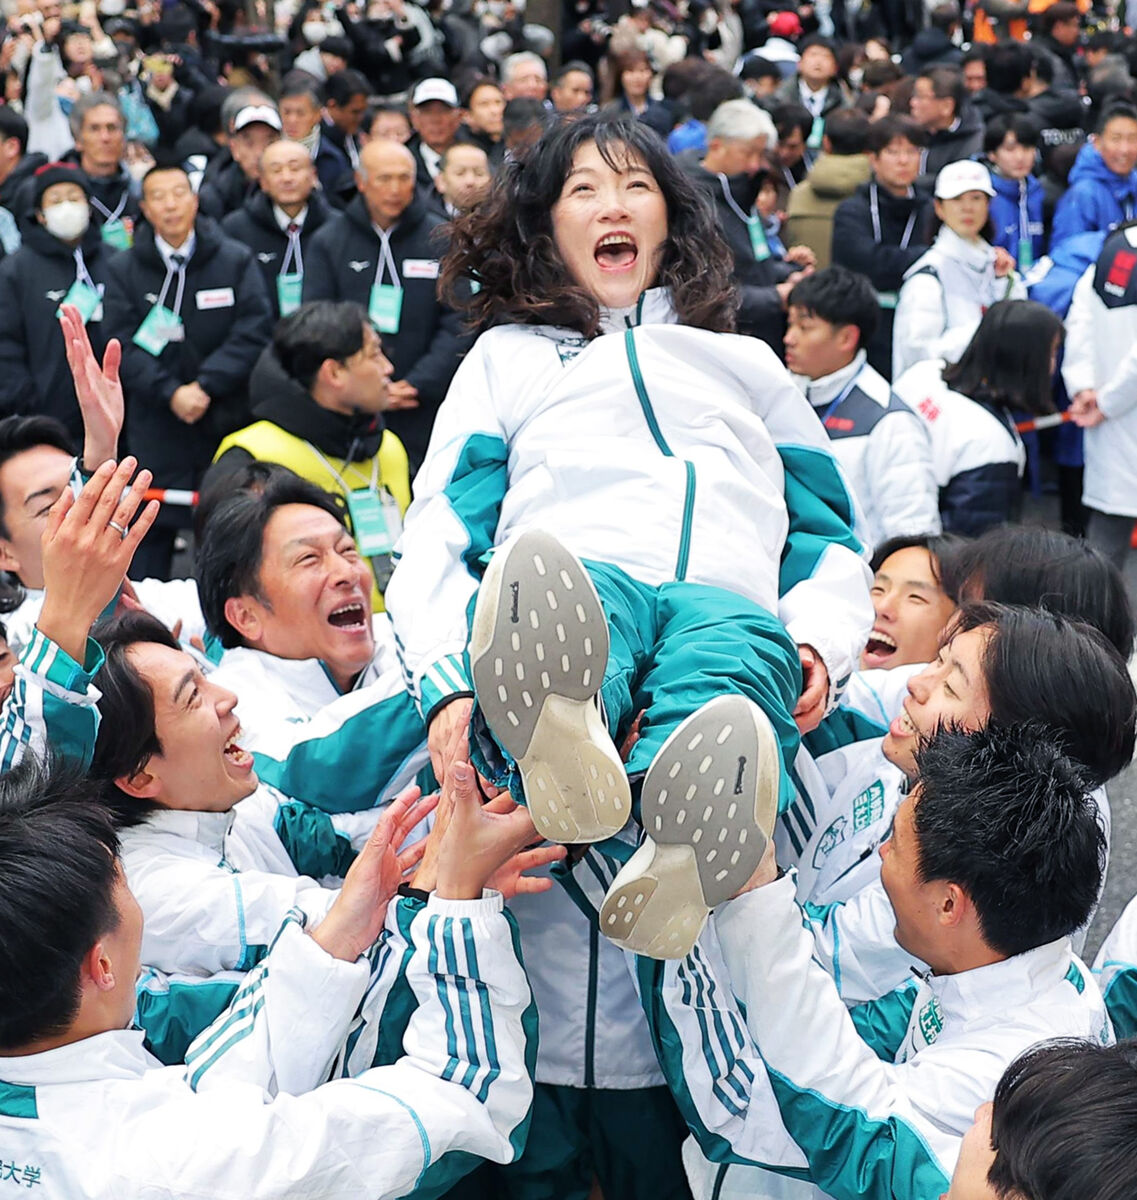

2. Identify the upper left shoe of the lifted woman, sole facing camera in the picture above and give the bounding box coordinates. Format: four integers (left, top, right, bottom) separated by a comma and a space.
470, 530, 632, 844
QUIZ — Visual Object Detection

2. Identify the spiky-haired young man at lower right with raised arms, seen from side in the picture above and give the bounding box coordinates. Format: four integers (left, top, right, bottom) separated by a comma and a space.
623, 724, 1112, 1200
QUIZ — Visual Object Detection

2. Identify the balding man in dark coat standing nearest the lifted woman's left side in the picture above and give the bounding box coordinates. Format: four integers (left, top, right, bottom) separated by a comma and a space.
303, 139, 467, 468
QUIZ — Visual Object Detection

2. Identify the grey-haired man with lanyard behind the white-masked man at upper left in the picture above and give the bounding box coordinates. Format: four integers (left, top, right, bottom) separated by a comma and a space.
64, 91, 140, 250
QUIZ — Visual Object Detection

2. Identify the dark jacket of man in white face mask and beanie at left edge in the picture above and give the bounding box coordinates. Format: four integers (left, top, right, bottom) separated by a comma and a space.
0, 217, 115, 442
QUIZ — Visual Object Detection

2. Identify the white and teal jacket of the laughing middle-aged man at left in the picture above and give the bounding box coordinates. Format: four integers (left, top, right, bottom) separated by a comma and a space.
210, 613, 429, 812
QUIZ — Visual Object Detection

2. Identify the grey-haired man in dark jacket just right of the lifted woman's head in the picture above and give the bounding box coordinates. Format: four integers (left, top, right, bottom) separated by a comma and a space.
680, 100, 812, 354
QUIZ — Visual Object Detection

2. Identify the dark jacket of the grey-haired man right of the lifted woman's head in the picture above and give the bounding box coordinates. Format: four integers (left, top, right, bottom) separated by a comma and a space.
680, 156, 794, 355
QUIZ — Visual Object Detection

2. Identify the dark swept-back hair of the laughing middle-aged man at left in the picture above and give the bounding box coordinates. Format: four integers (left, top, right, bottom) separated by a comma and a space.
197, 472, 348, 649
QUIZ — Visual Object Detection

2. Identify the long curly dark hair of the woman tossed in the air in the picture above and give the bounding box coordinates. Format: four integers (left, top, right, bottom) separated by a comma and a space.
440, 114, 738, 337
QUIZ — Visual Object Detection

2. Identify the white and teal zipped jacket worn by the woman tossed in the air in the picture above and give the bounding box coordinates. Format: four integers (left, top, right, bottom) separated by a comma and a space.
386, 289, 872, 716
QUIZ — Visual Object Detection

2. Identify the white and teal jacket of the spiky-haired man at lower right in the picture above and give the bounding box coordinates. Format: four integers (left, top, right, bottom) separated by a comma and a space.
637, 876, 1113, 1200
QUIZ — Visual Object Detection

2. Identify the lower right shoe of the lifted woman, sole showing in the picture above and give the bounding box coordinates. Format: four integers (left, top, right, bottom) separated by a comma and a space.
600, 694, 781, 959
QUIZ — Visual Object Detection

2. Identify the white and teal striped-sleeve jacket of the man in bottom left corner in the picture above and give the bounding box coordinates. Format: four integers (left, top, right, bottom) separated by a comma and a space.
0, 893, 535, 1200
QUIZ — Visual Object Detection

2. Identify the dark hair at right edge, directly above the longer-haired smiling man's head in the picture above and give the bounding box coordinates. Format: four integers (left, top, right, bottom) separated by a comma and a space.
944, 524, 1133, 662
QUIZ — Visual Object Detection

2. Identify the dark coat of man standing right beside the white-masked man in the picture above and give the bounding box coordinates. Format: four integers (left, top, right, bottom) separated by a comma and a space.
107, 217, 272, 494
